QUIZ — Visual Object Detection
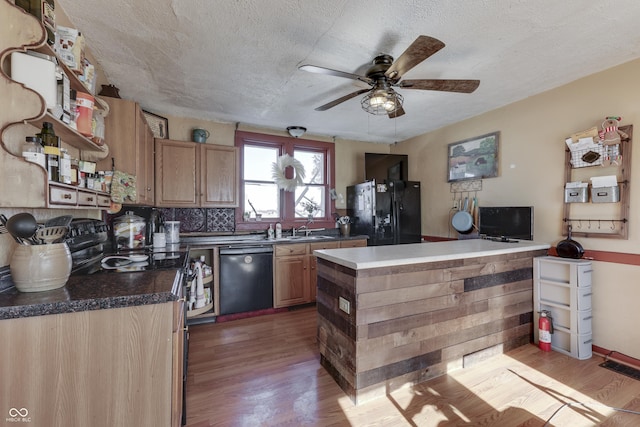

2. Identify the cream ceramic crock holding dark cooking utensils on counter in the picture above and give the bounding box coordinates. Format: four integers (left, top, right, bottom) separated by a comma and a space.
9, 243, 71, 292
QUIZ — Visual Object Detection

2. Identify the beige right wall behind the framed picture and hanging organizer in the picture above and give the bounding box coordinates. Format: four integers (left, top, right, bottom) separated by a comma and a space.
391, 56, 640, 358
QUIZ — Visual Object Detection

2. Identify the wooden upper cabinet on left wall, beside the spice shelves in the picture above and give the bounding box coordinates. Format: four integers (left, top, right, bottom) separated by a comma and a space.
98, 97, 154, 205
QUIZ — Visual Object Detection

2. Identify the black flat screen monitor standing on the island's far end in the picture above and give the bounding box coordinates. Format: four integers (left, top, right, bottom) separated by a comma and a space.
478, 206, 533, 240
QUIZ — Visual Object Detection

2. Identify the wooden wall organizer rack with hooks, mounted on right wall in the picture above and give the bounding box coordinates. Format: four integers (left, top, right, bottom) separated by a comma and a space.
562, 125, 633, 240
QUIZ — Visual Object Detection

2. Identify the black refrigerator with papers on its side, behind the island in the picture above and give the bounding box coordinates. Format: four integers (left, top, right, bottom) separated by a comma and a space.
347, 181, 422, 246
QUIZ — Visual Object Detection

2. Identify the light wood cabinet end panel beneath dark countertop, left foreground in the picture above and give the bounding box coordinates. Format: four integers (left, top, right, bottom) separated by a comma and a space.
0, 302, 183, 427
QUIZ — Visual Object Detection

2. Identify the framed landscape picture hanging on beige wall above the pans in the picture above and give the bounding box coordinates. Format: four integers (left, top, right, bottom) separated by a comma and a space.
447, 132, 500, 182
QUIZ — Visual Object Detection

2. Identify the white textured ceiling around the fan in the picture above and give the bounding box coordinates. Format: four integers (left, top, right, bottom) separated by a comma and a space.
57, 0, 640, 143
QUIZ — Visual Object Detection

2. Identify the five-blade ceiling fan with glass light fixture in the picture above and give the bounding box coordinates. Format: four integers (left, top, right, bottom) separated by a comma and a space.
298, 36, 480, 119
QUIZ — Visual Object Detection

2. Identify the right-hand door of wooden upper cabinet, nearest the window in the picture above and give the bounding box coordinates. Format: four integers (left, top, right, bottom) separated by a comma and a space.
200, 144, 240, 207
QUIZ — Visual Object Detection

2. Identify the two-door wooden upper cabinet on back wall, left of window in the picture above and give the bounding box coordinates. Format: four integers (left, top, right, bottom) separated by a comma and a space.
155, 139, 239, 207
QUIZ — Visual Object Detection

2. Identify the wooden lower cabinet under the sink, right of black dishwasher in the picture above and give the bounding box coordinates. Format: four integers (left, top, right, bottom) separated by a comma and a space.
273, 239, 367, 308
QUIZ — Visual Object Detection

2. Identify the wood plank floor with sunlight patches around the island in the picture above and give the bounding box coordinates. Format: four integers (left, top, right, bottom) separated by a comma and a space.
187, 307, 640, 427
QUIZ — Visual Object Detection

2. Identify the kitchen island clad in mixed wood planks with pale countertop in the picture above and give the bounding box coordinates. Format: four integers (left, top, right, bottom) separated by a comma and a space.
314, 239, 550, 404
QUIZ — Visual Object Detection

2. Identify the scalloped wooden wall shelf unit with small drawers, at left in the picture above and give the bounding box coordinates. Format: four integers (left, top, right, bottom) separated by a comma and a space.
0, 2, 109, 209
